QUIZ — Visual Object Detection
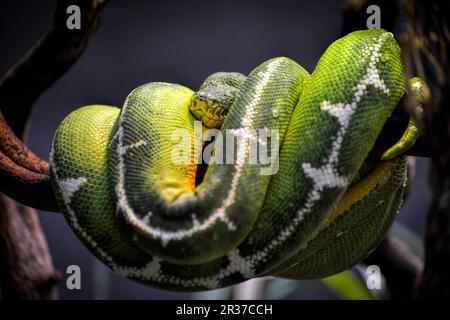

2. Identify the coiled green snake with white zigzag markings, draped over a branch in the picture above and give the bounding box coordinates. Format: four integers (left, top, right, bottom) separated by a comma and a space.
50, 30, 424, 291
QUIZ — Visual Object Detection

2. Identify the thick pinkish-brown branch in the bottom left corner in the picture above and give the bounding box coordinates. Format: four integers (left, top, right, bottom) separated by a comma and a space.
0, 194, 59, 299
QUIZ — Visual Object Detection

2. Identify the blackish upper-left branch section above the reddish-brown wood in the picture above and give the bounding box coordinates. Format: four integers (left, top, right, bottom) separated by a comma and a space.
0, 0, 105, 137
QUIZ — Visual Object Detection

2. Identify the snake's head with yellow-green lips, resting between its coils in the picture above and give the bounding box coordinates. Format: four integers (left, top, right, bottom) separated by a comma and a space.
189, 72, 247, 128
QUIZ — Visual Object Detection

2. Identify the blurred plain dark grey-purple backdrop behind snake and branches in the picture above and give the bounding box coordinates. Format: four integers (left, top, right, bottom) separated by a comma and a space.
0, 0, 429, 299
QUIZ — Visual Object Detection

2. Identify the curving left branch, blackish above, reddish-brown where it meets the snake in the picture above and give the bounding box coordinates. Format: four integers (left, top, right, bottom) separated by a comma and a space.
0, 0, 104, 215
